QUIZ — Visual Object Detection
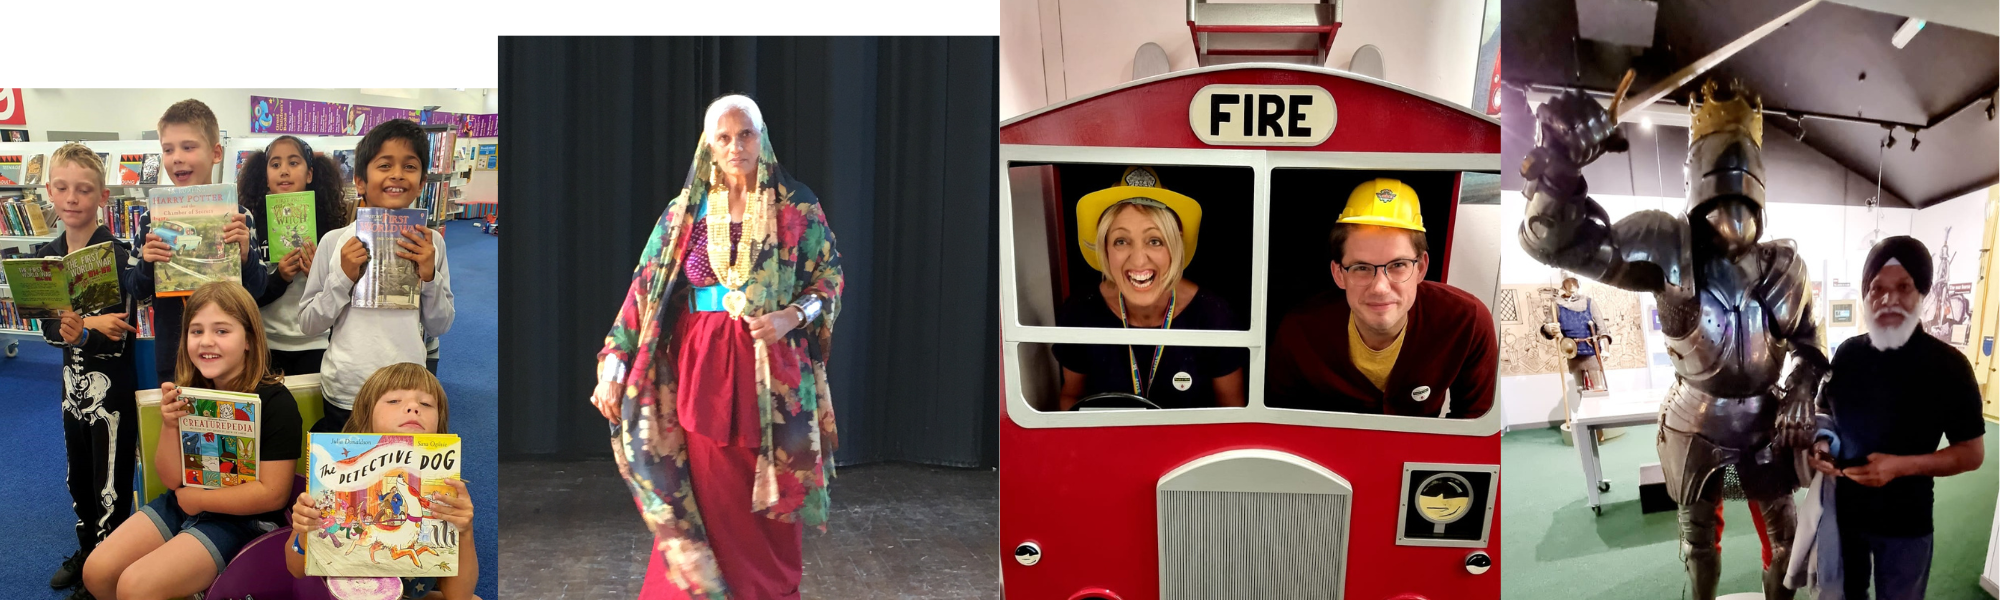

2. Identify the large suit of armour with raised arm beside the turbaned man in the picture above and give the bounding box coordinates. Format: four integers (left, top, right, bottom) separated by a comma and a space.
1520, 82, 1828, 600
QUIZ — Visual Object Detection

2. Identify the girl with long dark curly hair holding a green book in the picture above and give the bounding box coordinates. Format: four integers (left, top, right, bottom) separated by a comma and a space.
236, 136, 350, 374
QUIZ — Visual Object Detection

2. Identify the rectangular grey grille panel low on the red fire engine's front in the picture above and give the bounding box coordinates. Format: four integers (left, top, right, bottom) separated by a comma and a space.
1160, 492, 1348, 600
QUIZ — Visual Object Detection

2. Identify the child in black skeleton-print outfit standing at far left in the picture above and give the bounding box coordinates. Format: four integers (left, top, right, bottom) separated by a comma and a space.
34, 142, 138, 598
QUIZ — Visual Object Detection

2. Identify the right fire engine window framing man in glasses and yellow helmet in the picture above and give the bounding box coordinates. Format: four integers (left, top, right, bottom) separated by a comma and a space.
1264, 168, 1498, 418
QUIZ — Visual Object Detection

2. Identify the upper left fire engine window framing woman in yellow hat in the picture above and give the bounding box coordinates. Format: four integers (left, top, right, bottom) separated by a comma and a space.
1008, 164, 1254, 330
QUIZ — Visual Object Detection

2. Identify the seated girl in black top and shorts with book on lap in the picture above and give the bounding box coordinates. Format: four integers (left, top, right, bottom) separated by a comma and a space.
84, 282, 304, 598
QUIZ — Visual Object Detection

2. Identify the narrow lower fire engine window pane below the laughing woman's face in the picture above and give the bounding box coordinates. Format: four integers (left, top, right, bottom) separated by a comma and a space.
1020, 344, 1250, 412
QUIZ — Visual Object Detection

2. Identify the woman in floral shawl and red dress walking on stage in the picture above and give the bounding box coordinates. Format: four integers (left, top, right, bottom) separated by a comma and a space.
592, 96, 842, 600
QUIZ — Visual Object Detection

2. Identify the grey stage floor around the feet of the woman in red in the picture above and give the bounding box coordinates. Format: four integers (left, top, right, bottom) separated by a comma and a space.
500, 460, 1000, 600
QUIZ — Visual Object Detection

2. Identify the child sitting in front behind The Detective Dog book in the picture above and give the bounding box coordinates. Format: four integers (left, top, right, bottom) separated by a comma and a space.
284, 362, 480, 600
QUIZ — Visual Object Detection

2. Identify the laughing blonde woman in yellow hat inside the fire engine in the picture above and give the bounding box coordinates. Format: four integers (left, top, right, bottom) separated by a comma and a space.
1054, 190, 1248, 410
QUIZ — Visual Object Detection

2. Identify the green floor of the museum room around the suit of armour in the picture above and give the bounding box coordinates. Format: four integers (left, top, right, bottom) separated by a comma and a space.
1500, 422, 2000, 600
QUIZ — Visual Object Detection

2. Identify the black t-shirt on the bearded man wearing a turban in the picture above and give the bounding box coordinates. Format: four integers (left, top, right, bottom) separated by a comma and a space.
1820, 330, 1986, 536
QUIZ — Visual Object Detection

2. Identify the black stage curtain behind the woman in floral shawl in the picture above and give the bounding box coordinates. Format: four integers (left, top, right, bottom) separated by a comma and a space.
500, 38, 1000, 466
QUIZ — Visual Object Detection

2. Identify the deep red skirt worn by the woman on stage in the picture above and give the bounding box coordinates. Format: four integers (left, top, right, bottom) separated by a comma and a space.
640, 312, 804, 600
